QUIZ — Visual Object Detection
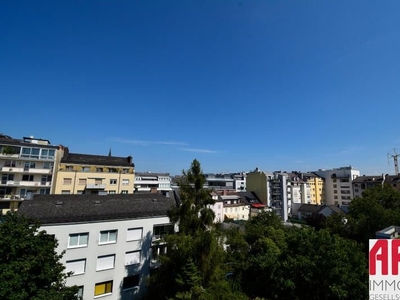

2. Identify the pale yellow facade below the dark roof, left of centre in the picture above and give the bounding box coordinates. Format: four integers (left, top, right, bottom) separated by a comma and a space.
54, 163, 135, 194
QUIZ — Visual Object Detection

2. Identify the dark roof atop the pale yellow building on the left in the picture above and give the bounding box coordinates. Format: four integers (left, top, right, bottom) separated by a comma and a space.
61, 152, 135, 167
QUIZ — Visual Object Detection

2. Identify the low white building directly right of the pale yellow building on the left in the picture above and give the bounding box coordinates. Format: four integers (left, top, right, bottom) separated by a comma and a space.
134, 172, 172, 192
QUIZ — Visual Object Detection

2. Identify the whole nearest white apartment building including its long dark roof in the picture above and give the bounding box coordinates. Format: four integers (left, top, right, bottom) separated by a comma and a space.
19, 194, 175, 300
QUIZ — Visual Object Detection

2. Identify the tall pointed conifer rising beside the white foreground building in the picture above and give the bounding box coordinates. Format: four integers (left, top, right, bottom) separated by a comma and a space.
148, 159, 247, 299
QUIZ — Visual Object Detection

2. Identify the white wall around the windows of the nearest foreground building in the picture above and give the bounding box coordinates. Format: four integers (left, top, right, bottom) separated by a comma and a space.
41, 217, 169, 300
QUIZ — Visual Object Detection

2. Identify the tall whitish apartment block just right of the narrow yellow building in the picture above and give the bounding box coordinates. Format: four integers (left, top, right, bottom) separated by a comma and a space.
313, 166, 360, 205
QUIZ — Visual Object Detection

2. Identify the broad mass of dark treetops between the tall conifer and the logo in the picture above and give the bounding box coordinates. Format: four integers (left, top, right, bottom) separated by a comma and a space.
227, 214, 368, 300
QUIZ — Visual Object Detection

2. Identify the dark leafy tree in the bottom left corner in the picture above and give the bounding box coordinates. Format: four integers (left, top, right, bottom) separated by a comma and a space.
0, 212, 77, 300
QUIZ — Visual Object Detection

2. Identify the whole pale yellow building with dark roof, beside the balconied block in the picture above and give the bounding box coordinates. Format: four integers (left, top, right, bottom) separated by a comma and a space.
54, 148, 135, 194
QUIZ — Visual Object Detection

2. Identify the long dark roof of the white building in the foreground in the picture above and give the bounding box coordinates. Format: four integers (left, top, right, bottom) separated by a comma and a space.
18, 194, 176, 224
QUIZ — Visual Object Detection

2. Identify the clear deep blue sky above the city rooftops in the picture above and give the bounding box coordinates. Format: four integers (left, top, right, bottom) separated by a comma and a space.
0, 0, 400, 174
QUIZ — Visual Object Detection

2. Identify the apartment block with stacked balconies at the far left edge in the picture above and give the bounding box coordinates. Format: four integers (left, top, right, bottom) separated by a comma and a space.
0, 135, 62, 213
